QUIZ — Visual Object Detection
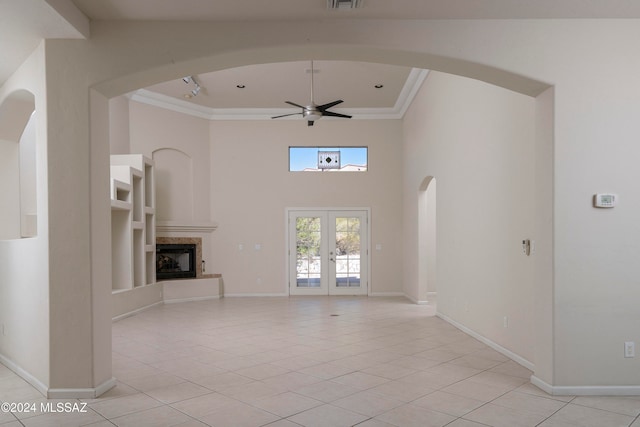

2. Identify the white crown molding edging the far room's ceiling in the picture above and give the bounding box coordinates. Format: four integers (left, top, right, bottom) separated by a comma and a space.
128, 68, 429, 120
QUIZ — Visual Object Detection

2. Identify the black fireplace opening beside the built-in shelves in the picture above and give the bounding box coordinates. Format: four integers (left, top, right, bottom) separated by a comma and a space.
156, 244, 196, 280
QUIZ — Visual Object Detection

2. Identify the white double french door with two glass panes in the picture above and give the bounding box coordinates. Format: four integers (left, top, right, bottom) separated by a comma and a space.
288, 210, 369, 295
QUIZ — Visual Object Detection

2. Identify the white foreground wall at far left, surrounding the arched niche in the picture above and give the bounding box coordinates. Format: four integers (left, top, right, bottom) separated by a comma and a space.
0, 45, 50, 391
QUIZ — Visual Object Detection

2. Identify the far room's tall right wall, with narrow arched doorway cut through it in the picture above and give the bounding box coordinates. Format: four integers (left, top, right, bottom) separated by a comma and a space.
404, 72, 536, 362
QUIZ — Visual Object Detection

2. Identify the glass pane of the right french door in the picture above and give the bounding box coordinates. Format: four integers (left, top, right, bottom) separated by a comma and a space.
335, 217, 360, 288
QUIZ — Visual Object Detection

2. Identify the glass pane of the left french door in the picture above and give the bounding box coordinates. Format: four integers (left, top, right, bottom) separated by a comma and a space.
296, 217, 322, 288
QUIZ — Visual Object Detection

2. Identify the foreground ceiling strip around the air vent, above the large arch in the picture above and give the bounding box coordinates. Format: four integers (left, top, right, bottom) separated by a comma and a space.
73, 0, 640, 21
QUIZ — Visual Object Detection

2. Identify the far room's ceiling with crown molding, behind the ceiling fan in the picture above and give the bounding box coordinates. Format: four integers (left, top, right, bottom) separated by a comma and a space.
132, 61, 426, 120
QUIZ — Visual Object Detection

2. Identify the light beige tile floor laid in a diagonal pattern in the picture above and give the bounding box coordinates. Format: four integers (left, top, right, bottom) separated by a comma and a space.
0, 297, 640, 427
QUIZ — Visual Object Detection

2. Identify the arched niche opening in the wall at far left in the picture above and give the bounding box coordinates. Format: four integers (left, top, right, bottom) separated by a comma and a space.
0, 89, 37, 240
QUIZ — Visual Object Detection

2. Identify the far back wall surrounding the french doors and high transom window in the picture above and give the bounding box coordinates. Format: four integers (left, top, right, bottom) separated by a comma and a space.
211, 119, 402, 294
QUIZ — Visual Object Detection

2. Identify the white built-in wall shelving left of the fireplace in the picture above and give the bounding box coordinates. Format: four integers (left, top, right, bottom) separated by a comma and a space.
111, 154, 156, 292
